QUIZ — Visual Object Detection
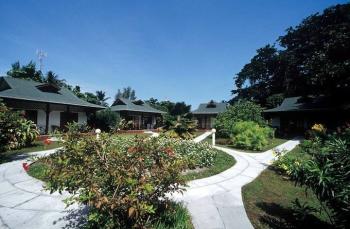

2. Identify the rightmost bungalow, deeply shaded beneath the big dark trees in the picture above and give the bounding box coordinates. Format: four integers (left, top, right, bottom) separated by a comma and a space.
263, 96, 350, 134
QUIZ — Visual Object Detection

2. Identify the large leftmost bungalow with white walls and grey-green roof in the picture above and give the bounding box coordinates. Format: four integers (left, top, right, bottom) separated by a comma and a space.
0, 77, 105, 134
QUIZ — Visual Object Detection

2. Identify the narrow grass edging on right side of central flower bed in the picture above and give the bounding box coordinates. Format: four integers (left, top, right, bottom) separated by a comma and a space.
184, 150, 236, 181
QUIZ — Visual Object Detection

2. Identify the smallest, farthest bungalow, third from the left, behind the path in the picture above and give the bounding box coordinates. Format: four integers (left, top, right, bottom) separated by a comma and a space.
192, 101, 228, 129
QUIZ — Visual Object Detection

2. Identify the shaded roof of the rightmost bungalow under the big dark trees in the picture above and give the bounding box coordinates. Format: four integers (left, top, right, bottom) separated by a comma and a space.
264, 96, 336, 113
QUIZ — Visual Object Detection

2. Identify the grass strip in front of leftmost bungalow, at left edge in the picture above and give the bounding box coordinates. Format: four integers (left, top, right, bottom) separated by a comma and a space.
0, 141, 61, 164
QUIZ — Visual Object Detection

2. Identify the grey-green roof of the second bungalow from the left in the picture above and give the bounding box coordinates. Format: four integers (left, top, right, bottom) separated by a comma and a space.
110, 98, 166, 114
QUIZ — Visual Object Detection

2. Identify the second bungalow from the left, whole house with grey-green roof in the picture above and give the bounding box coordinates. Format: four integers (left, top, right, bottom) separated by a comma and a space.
110, 98, 166, 130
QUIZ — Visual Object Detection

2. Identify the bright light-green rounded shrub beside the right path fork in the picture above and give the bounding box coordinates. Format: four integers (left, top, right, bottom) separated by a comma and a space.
230, 121, 274, 150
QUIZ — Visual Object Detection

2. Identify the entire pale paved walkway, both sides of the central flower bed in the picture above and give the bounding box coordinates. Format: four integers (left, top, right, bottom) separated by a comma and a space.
0, 137, 299, 229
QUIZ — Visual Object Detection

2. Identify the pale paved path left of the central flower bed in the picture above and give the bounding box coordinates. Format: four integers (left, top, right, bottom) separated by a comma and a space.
0, 150, 83, 229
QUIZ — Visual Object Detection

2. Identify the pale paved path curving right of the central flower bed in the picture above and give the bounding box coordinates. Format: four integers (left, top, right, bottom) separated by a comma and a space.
173, 140, 299, 229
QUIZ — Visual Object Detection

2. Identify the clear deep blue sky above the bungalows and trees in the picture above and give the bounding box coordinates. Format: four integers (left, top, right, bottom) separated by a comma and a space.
0, 0, 347, 108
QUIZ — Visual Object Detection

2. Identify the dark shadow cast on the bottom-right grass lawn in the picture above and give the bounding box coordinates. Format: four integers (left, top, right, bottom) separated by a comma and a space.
256, 202, 332, 229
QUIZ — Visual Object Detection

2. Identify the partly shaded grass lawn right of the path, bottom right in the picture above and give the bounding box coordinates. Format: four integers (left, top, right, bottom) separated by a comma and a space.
242, 147, 330, 228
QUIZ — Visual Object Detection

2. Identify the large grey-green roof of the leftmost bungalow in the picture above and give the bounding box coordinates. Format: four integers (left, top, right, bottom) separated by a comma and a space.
0, 77, 105, 109
